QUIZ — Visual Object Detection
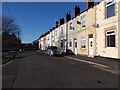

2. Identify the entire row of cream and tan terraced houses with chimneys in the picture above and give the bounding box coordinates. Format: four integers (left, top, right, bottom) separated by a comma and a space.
39, 0, 120, 59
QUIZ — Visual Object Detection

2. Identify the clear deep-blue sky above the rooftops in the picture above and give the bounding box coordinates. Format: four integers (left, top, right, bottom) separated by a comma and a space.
2, 2, 86, 43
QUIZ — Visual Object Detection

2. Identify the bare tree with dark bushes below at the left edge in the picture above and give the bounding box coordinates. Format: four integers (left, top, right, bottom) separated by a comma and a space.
1, 16, 21, 50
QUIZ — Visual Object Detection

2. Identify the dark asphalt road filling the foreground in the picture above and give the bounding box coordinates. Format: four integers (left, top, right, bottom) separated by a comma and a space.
2, 51, 118, 88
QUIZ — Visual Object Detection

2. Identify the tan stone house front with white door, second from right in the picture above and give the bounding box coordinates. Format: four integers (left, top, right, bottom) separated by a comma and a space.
77, 2, 96, 57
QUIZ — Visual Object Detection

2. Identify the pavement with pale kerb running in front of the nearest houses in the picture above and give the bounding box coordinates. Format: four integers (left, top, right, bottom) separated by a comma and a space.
65, 55, 120, 75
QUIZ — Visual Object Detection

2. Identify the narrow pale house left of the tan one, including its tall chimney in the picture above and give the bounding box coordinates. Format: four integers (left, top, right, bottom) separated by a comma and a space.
68, 6, 80, 55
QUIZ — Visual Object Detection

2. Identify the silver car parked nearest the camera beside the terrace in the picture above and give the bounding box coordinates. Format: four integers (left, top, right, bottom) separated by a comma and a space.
45, 46, 62, 56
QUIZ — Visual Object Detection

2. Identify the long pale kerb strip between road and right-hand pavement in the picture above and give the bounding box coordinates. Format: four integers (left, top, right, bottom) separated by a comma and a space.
65, 56, 110, 68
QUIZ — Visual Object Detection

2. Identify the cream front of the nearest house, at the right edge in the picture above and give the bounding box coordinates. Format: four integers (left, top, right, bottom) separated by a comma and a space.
96, 0, 120, 58
